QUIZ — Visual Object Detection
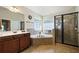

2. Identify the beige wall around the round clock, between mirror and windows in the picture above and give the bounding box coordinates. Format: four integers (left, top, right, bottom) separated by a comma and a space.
17, 6, 40, 31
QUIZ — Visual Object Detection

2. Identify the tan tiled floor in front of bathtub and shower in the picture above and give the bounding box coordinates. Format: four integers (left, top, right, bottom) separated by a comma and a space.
22, 43, 79, 53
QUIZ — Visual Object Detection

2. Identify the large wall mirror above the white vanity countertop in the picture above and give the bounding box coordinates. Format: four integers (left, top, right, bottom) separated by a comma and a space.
0, 7, 25, 32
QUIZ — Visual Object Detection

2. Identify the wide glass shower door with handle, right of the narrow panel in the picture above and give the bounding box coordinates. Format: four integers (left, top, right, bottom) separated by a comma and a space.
63, 13, 78, 46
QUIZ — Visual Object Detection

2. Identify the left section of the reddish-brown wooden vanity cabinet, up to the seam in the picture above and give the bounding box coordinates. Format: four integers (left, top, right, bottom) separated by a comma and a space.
0, 36, 19, 53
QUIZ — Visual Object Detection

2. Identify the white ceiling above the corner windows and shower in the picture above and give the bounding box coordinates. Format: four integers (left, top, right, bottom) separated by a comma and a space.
25, 6, 75, 16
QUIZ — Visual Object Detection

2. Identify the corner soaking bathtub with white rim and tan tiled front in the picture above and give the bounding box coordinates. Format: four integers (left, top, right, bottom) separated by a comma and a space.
31, 34, 54, 46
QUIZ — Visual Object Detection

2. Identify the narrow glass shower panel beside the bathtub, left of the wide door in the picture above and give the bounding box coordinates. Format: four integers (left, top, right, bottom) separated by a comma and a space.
54, 15, 62, 43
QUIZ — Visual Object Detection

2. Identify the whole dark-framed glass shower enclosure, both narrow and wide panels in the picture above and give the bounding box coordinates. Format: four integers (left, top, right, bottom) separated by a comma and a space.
54, 12, 78, 46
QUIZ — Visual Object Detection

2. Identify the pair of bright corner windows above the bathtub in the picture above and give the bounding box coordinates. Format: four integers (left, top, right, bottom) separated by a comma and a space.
34, 19, 54, 32
